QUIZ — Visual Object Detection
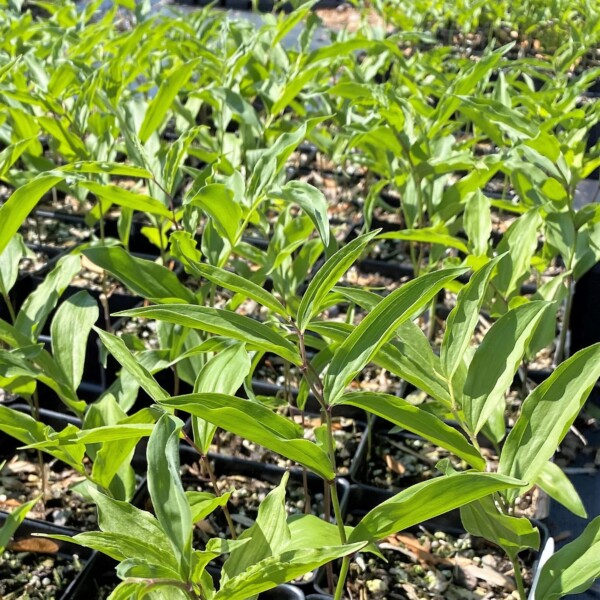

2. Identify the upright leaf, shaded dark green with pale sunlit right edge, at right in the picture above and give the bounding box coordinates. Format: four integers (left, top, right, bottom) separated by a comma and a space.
462, 300, 550, 434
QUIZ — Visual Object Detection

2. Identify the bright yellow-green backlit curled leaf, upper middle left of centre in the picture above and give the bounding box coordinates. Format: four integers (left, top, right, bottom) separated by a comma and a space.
188, 183, 242, 246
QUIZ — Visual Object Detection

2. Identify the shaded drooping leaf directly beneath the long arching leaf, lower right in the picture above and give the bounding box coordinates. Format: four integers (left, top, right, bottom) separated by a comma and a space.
460, 496, 540, 560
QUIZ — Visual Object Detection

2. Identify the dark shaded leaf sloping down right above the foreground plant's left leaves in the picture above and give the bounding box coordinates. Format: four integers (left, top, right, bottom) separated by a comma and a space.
83, 246, 196, 304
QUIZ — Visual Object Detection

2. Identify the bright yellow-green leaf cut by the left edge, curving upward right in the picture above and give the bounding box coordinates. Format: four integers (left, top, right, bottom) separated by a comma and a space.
0, 171, 64, 253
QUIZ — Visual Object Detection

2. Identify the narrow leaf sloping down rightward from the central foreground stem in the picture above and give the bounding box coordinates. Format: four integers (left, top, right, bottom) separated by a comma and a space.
336, 392, 485, 471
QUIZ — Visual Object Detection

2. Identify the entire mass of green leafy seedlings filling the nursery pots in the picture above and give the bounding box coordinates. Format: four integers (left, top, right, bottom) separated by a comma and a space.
0, 0, 600, 600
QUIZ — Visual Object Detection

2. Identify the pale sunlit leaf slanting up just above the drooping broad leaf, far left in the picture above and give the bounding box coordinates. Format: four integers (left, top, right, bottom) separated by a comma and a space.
15, 256, 81, 340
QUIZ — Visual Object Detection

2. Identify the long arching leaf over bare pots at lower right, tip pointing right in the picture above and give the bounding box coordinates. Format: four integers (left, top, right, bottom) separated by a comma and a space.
348, 471, 524, 543
